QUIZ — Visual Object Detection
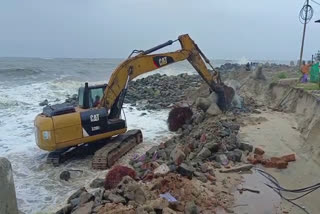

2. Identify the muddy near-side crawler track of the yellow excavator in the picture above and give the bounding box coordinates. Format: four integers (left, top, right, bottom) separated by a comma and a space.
92, 129, 143, 170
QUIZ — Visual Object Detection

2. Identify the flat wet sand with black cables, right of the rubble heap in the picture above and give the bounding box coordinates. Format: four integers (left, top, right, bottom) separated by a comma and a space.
234, 111, 320, 214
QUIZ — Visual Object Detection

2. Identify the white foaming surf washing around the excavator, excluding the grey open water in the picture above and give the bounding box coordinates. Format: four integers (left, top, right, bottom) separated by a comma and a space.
0, 80, 172, 213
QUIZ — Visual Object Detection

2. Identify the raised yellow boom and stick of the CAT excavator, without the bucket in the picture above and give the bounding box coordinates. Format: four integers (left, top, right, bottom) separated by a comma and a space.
101, 34, 231, 119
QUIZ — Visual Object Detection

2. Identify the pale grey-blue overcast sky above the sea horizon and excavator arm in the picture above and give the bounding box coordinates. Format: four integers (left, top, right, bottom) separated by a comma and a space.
0, 0, 320, 60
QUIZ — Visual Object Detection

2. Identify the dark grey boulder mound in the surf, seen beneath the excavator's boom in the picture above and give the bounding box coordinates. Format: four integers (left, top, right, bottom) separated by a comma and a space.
125, 74, 203, 110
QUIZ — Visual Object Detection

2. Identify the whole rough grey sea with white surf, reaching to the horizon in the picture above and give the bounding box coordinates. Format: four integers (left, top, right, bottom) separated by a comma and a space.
0, 58, 289, 214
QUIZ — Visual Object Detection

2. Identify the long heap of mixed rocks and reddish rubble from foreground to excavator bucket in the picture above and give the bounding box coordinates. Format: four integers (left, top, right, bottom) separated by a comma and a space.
57, 105, 253, 214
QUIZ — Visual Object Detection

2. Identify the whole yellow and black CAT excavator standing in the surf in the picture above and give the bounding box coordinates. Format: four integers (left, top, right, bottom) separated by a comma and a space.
34, 34, 234, 169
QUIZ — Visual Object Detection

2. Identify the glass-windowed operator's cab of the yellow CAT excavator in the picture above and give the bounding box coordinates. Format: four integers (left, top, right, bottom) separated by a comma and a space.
78, 82, 107, 109
